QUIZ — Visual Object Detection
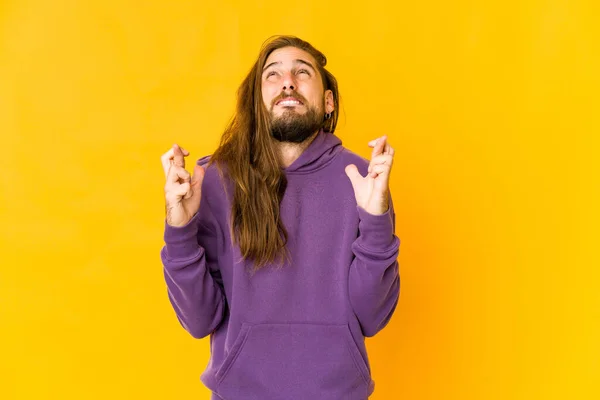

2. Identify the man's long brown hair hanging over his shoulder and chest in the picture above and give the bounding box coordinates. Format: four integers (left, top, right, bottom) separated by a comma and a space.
210, 36, 339, 271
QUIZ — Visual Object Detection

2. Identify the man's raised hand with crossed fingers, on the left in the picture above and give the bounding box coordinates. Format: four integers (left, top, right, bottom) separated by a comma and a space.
161, 144, 204, 227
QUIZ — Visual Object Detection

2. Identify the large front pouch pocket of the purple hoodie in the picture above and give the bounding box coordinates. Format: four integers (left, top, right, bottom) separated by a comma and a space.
216, 323, 371, 399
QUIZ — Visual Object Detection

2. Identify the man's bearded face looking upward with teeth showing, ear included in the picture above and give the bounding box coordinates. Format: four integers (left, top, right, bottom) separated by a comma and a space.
262, 47, 334, 143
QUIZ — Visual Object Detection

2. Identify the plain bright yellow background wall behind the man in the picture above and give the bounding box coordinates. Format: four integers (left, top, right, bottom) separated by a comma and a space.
0, 0, 600, 400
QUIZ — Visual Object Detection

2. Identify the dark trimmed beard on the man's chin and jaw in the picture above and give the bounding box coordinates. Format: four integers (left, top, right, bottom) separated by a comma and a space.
270, 103, 325, 143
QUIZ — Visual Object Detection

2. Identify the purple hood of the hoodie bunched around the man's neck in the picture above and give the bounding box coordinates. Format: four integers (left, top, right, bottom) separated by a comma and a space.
282, 128, 343, 174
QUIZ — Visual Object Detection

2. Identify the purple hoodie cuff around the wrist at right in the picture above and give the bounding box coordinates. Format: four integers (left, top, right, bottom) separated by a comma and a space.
357, 206, 394, 251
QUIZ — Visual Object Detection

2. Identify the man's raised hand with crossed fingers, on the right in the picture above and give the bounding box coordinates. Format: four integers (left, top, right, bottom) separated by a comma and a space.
346, 136, 394, 215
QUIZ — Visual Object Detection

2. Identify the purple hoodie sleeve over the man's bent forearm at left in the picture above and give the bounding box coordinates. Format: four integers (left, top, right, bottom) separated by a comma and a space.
161, 192, 227, 339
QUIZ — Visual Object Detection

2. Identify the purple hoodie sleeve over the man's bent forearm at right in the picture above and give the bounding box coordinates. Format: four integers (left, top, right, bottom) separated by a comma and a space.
349, 197, 400, 337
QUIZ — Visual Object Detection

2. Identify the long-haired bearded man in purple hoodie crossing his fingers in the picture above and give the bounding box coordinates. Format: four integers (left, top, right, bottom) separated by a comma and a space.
161, 36, 400, 400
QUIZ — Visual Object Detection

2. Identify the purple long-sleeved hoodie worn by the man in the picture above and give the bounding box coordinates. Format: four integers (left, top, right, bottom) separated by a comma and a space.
161, 131, 400, 400
